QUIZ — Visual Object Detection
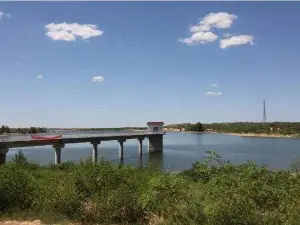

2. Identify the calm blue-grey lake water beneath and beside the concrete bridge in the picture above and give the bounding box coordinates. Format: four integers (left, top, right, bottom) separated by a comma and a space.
7, 133, 300, 172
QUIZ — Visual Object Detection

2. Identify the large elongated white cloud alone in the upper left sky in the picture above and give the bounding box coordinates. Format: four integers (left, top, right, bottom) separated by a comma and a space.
45, 23, 103, 41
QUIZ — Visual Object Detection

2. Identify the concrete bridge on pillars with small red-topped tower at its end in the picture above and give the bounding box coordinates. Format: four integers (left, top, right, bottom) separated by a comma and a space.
0, 122, 164, 164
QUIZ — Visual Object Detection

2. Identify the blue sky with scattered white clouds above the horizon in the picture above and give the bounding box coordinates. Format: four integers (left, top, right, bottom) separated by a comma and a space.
0, 2, 300, 127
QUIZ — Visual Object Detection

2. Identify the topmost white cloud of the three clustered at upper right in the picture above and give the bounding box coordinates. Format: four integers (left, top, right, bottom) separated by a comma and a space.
190, 12, 238, 33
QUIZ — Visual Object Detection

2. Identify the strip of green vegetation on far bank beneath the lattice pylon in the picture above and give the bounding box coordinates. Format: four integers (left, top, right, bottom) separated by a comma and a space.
166, 122, 300, 135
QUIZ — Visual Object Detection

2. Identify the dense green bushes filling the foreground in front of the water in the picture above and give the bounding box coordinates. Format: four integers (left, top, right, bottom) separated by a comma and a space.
0, 152, 300, 225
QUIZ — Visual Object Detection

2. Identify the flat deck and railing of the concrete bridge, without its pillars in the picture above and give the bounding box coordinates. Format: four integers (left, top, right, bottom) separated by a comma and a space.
0, 131, 164, 148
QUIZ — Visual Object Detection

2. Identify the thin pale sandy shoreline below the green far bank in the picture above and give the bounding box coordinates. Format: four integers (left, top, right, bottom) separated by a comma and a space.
165, 130, 300, 139
